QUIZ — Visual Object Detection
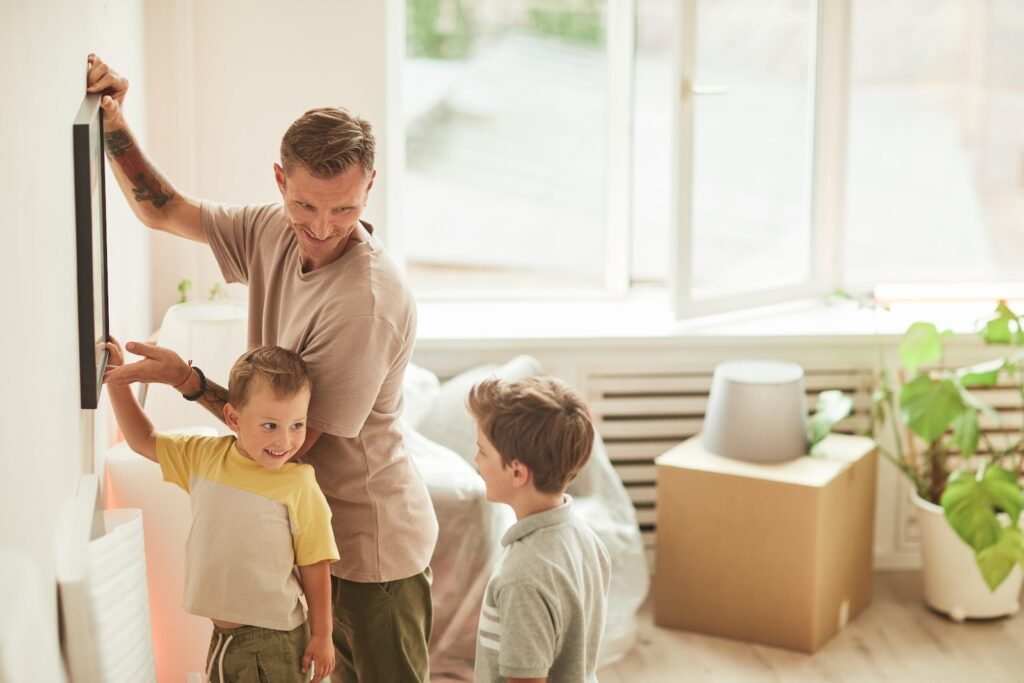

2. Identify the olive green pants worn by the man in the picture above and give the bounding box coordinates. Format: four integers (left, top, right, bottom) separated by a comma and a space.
331, 567, 433, 683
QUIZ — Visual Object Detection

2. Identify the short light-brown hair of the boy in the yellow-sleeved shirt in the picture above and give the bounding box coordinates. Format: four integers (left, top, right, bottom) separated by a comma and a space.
227, 346, 312, 409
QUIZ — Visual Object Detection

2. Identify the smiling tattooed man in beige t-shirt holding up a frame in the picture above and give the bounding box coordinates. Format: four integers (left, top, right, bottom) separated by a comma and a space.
87, 55, 437, 681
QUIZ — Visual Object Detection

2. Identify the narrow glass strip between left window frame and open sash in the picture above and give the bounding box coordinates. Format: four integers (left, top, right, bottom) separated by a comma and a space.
631, 0, 678, 285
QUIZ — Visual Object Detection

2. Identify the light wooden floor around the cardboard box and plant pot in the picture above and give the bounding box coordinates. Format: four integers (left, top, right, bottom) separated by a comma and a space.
598, 571, 1024, 683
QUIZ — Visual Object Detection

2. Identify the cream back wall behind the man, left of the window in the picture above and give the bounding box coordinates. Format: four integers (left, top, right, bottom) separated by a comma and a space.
145, 0, 403, 325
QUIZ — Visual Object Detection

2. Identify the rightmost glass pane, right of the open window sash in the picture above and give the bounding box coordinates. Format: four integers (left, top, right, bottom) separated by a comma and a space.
845, 0, 1024, 285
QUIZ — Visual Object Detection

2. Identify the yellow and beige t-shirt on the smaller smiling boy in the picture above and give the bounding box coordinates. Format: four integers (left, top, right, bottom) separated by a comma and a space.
157, 434, 338, 631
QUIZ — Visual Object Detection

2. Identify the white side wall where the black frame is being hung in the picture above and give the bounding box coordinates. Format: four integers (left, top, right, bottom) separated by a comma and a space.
0, 0, 150, 671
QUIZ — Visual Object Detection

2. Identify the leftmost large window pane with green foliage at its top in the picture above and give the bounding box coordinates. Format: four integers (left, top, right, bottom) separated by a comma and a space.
403, 0, 607, 291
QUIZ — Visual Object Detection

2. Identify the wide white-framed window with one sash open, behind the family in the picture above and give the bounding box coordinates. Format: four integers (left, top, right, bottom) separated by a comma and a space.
403, 0, 1024, 317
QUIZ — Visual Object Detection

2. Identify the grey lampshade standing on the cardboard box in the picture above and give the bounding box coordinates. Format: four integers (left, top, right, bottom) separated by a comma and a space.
701, 360, 807, 463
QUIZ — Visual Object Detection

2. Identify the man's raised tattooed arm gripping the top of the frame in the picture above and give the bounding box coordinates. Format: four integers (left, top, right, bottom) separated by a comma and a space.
86, 54, 206, 243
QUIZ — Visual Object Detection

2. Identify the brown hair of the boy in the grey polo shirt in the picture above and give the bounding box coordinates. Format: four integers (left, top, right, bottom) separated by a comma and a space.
468, 377, 594, 494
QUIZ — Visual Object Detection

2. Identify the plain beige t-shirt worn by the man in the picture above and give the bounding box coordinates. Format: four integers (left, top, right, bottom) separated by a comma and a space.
202, 202, 437, 583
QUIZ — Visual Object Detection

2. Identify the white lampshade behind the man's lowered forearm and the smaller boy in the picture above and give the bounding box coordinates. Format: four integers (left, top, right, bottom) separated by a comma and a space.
145, 301, 248, 433
